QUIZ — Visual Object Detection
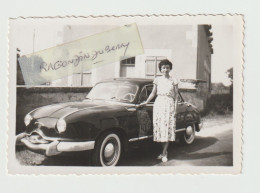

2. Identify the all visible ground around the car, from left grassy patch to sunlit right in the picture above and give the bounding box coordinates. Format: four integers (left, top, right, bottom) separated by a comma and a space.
16, 115, 233, 166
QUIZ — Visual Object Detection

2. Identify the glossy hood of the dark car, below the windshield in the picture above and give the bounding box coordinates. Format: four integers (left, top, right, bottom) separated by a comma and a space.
31, 101, 124, 119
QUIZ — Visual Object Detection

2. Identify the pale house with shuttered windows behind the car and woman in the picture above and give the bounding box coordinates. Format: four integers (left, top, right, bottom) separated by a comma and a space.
16, 25, 213, 110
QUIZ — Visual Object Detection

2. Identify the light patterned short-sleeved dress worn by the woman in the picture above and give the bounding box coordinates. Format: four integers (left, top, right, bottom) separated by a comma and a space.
153, 77, 178, 142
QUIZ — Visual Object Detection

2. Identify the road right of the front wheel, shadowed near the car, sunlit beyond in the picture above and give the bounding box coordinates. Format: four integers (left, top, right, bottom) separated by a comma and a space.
121, 116, 233, 166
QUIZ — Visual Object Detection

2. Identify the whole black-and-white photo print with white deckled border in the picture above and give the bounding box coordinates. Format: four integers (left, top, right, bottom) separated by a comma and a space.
8, 15, 244, 174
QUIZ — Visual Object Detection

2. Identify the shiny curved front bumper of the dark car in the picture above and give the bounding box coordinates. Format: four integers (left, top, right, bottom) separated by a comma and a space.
16, 133, 95, 156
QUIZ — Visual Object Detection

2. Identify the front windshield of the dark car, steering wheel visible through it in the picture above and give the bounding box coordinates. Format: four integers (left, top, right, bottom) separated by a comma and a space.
86, 82, 138, 102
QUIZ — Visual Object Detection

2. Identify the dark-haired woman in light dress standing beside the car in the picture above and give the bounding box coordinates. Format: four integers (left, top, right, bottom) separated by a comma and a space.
141, 60, 178, 162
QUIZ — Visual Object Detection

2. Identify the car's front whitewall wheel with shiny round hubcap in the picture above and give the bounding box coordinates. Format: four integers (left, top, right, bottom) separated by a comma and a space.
92, 133, 122, 166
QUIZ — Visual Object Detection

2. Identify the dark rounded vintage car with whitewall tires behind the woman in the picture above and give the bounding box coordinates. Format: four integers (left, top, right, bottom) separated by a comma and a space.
16, 78, 201, 166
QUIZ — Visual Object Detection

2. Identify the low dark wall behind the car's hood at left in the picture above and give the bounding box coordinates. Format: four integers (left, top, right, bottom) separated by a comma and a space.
16, 87, 91, 134
